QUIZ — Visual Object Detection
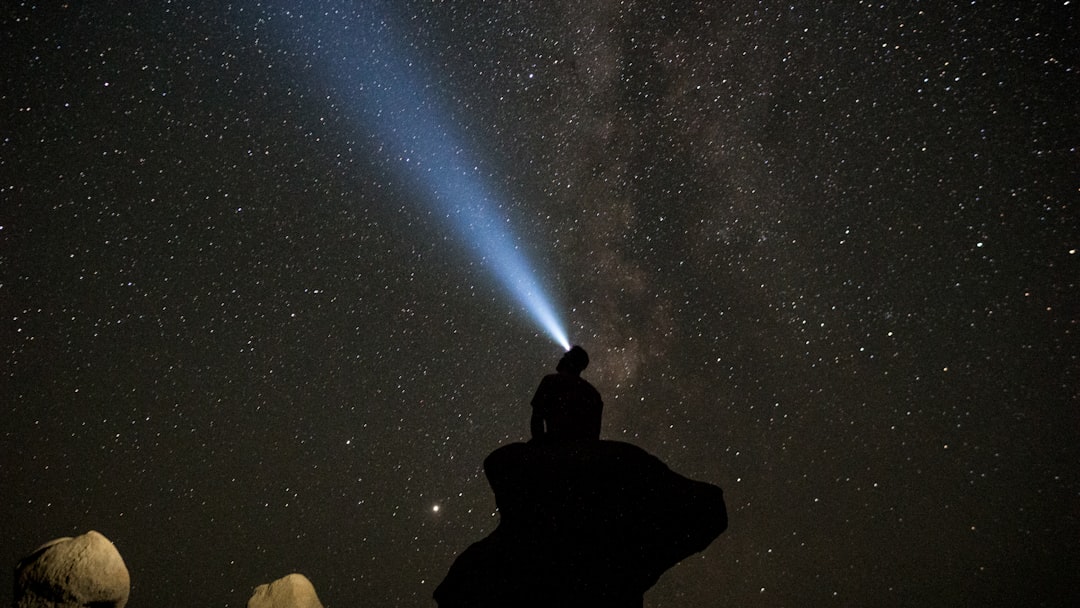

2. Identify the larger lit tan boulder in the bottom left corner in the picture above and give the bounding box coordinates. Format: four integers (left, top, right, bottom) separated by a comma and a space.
14, 530, 131, 608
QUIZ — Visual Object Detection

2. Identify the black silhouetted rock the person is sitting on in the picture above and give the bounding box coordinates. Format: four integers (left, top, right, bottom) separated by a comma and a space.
434, 441, 727, 608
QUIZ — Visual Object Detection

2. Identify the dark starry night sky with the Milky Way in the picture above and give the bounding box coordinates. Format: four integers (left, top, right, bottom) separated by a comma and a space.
0, 0, 1080, 608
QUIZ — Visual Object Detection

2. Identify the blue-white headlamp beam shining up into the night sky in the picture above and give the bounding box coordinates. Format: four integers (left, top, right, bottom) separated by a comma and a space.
270, 1, 570, 350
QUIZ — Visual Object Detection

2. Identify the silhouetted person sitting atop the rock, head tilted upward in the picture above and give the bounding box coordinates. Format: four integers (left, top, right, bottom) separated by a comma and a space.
529, 346, 604, 441
